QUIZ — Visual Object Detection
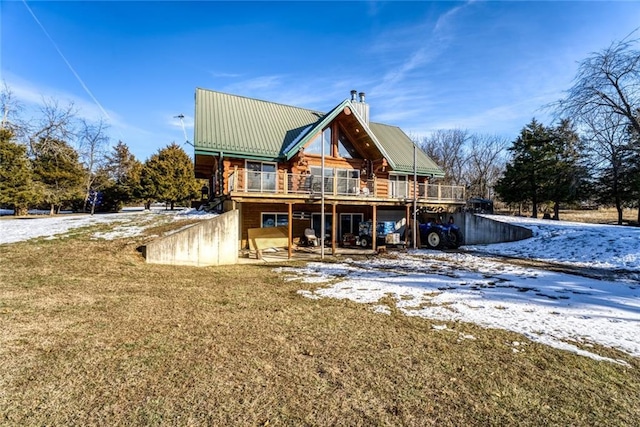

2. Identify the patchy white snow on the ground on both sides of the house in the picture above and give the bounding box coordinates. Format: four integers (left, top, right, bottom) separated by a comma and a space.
0, 210, 640, 363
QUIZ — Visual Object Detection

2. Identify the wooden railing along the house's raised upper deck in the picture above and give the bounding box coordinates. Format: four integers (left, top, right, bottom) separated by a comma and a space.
228, 171, 465, 203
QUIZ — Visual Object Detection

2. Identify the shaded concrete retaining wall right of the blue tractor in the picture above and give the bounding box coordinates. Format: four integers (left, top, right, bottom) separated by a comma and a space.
450, 213, 533, 245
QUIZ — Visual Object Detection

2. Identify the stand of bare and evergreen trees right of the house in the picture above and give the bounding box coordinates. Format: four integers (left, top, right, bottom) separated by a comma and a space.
415, 35, 640, 224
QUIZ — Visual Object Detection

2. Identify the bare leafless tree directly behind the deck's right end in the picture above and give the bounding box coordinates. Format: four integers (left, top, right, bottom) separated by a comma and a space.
417, 129, 469, 185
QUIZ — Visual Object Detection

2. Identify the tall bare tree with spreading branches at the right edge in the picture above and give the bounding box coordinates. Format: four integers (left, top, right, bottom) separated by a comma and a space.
555, 34, 640, 223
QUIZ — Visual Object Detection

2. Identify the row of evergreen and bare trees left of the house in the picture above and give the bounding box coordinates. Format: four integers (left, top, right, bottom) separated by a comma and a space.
0, 84, 200, 215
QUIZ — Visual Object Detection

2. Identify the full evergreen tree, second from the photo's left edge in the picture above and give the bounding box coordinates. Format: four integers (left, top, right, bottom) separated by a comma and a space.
32, 139, 85, 214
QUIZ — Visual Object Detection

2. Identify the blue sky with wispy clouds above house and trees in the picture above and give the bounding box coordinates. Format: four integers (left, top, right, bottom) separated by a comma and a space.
0, 0, 640, 161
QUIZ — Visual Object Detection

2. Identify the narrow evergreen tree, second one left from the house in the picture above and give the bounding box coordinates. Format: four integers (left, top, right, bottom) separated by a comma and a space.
104, 141, 144, 211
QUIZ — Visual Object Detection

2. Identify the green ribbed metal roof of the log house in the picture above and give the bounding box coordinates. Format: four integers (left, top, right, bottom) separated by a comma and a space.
194, 88, 444, 177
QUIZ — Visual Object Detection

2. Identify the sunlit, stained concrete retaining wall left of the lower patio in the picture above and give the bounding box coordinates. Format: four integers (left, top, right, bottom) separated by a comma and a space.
144, 210, 239, 267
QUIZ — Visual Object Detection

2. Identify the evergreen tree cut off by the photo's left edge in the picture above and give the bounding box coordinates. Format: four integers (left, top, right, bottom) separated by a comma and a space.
0, 128, 38, 215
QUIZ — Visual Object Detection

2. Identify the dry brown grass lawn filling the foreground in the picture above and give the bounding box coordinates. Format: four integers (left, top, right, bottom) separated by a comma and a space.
0, 222, 640, 426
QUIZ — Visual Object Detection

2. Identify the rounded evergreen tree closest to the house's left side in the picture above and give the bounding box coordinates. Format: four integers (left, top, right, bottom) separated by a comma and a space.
142, 143, 200, 209
